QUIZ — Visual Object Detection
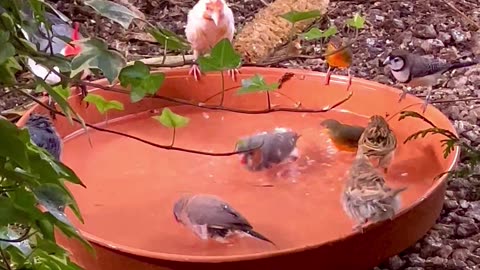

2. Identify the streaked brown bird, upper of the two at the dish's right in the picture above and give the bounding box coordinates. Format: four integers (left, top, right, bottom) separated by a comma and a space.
358, 115, 397, 173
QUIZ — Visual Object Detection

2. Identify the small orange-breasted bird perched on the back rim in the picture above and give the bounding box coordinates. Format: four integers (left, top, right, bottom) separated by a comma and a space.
325, 36, 353, 90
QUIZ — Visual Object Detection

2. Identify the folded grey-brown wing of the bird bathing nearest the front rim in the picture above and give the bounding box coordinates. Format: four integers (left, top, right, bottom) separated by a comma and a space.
186, 195, 252, 229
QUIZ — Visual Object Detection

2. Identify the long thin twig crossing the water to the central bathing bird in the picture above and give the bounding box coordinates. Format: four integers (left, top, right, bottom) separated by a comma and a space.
17, 90, 263, 156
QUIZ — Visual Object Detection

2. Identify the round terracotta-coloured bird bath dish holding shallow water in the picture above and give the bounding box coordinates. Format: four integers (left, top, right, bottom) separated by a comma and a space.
19, 68, 459, 270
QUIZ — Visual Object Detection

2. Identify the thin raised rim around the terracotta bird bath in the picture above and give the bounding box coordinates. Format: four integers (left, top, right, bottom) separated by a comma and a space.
17, 67, 460, 263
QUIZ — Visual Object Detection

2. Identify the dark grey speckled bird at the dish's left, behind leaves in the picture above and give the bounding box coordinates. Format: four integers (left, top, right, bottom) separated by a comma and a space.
25, 113, 62, 160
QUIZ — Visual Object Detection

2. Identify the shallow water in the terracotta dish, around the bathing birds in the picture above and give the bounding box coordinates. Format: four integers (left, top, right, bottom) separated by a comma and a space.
62, 106, 441, 256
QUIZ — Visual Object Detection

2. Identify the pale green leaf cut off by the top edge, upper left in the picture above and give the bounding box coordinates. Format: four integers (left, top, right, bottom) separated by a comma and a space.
85, 0, 139, 29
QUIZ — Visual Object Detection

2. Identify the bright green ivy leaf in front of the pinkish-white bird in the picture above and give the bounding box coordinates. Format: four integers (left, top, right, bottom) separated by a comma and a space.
197, 38, 242, 72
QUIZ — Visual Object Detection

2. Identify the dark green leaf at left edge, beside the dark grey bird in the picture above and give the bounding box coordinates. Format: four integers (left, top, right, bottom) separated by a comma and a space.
0, 119, 30, 168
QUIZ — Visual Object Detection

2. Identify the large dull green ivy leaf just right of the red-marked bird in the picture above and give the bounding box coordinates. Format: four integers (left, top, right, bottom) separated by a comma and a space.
70, 37, 127, 83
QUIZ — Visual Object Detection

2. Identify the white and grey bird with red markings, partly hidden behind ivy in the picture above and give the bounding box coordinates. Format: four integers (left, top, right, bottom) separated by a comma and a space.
20, 2, 89, 116
